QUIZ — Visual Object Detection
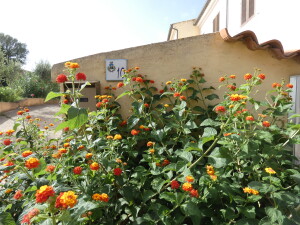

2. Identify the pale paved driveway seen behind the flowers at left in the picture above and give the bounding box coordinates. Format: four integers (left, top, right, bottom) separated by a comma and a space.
0, 104, 60, 132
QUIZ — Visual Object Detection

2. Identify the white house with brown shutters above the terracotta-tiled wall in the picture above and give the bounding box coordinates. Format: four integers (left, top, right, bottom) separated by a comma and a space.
168, 0, 300, 50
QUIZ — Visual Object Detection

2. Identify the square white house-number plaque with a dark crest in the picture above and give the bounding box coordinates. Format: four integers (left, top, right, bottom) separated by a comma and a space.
106, 59, 127, 81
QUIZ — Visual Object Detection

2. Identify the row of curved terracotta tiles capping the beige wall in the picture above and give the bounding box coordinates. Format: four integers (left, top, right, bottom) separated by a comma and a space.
220, 28, 300, 59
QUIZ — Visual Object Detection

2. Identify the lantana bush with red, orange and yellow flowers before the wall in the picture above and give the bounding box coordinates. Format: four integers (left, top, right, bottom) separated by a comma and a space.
0, 62, 300, 225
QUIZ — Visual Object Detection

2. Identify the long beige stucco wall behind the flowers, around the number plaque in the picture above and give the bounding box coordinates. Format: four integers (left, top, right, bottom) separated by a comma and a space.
52, 33, 300, 118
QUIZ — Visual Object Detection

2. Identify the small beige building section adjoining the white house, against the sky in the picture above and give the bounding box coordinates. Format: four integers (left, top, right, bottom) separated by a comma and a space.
169, 20, 200, 40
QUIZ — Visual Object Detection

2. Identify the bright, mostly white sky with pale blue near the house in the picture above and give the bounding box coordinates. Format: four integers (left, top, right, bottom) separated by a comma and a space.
0, 0, 205, 70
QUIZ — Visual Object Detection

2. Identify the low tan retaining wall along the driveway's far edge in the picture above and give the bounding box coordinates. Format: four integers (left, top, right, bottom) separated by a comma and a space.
0, 98, 59, 113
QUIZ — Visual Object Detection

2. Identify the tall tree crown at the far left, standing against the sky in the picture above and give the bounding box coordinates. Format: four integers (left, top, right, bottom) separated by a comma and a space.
0, 33, 29, 64
